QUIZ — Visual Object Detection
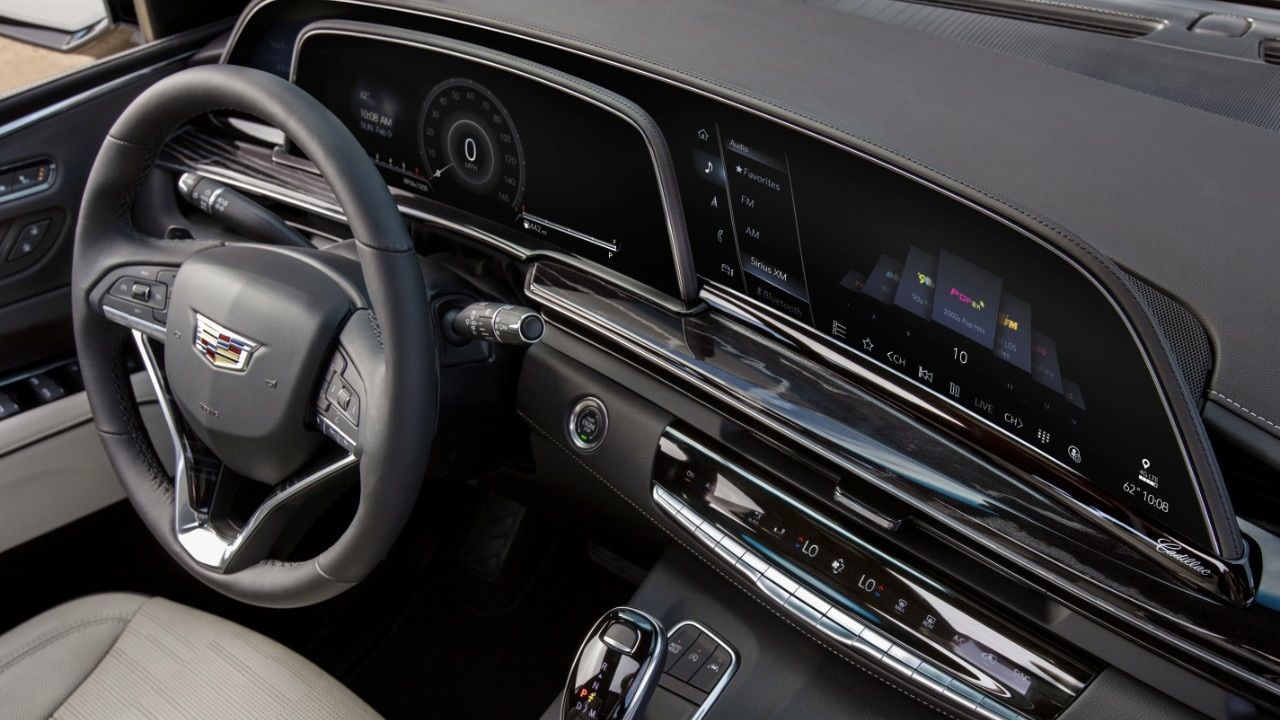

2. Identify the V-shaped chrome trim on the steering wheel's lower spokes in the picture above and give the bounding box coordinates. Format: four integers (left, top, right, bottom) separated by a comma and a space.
132, 329, 357, 573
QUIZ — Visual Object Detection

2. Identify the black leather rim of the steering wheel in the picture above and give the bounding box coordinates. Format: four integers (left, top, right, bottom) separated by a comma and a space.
73, 65, 438, 607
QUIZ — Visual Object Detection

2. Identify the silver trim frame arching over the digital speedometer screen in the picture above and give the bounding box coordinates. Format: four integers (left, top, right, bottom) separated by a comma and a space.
289, 27, 698, 302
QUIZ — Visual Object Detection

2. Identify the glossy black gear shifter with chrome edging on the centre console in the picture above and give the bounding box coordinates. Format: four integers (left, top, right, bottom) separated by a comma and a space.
561, 607, 667, 720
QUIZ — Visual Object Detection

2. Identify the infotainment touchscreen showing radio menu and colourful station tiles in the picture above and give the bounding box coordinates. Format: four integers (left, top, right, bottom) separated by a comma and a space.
664, 119, 1216, 551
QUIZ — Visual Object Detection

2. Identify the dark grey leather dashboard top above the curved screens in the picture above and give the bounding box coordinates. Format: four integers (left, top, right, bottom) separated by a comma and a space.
389, 0, 1280, 437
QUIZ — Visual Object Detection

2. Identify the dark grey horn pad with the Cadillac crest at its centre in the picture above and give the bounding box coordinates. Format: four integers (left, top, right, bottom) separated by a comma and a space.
165, 245, 352, 484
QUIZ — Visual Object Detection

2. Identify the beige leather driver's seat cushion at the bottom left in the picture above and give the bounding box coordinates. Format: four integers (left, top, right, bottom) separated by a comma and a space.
0, 593, 378, 720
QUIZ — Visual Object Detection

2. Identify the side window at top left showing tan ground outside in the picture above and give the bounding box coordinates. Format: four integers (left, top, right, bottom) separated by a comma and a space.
0, 0, 143, 96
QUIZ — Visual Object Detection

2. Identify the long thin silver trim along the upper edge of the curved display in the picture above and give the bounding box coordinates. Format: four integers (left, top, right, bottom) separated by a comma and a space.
221, 0, 1222, 555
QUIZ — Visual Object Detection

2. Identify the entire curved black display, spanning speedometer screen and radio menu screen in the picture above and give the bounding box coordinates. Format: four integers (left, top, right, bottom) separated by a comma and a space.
275, 23, 1239, 557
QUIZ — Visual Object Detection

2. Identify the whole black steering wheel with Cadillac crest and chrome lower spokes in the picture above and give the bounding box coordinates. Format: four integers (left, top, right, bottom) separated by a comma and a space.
73, 65, 439, 607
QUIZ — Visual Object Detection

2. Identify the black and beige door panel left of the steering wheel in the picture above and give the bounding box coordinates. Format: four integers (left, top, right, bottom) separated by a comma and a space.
0, 26, 225, 552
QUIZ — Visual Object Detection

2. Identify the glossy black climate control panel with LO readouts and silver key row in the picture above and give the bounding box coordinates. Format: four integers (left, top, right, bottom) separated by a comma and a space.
653, 428, 1091, 720
